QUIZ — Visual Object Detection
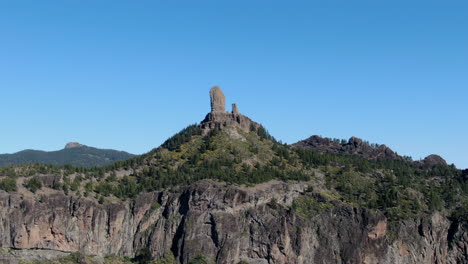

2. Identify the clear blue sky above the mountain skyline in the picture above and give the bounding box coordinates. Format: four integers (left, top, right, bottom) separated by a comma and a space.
0, 0, 468, 168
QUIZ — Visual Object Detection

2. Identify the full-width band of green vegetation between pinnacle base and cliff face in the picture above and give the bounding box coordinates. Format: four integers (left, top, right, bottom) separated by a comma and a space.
0, 122, 468, 226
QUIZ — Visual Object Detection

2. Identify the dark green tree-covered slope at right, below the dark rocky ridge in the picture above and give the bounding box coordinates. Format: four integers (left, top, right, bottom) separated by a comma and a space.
296, 149, 468, 221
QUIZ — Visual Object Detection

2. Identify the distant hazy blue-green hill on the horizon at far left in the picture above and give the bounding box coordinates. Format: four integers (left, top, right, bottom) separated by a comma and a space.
0, 142, 135, 167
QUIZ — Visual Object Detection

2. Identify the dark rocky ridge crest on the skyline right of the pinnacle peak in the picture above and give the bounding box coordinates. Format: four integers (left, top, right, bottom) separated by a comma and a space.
292, 135, 403, 160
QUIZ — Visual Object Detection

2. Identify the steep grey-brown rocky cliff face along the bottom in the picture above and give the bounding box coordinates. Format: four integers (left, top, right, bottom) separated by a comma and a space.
0, 180, 468, 263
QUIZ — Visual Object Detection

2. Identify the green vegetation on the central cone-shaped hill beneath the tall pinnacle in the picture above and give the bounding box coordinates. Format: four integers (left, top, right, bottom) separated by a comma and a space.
83, 125, 310, 199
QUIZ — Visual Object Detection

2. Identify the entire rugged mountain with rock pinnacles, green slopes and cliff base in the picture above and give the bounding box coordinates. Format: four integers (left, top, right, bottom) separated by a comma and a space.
0, 87, 468, 264
